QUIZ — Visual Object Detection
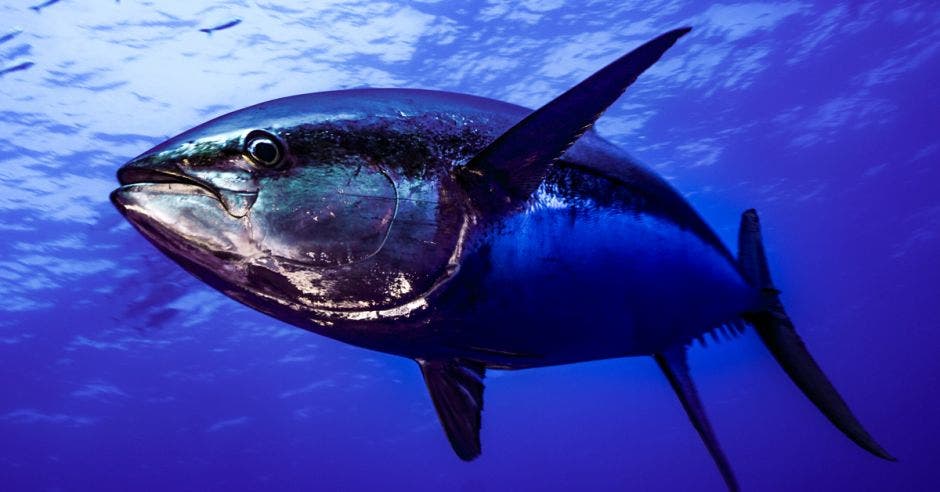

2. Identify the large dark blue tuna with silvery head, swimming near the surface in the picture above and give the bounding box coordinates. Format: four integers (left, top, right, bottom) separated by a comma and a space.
110, 27, 894, 490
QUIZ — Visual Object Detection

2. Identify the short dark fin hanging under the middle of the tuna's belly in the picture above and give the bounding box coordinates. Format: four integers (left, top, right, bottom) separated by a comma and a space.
418, 359, 486, 461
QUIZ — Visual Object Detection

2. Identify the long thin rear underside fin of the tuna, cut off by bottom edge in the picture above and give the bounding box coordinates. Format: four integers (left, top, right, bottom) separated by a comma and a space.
653, 347, 740, 491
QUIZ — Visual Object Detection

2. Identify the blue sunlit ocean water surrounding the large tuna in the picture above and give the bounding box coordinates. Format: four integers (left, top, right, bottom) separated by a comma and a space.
0, 0, 940, 491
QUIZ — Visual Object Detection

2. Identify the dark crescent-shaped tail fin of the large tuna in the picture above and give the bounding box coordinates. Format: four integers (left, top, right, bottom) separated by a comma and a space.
738, 209, 896, 461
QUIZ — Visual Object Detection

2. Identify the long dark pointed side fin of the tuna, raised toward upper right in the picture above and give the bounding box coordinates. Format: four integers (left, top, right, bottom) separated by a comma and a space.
458, 27, 691, 216
